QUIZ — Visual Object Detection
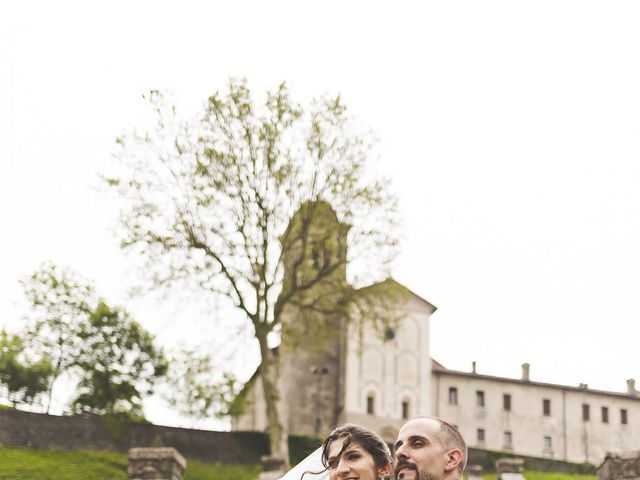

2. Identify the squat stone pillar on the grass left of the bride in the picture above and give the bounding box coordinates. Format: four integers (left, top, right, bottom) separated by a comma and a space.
127, 448, 187, 480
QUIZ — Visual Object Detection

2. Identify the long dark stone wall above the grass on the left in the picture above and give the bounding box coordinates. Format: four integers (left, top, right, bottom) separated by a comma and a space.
0, 409, 269, 464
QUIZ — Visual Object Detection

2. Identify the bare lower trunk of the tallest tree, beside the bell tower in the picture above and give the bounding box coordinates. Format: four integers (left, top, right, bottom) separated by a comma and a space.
259, 337, 289, 467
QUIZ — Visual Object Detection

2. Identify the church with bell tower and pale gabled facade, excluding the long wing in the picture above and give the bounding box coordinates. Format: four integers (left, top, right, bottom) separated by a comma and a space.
232, 202, 435, 441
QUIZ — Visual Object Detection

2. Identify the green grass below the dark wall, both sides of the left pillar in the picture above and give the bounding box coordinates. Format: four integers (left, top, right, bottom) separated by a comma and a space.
0, 448, 260, 480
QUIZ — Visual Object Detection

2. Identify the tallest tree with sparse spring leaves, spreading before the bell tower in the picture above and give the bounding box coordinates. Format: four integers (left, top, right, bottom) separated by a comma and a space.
104, 80, 396, 458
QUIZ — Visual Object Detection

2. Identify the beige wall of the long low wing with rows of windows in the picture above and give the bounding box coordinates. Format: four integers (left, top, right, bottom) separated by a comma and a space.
433, 372, 640, 464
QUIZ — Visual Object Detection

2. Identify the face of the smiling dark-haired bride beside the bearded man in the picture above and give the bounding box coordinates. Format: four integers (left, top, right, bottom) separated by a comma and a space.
327, 438, 383, 480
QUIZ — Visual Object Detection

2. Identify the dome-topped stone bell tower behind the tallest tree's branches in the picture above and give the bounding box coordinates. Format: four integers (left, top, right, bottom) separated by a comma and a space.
279, 201, 352, 435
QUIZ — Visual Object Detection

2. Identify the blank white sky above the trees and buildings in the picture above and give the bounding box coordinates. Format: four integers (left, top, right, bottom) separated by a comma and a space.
0, 0, 640, 423
